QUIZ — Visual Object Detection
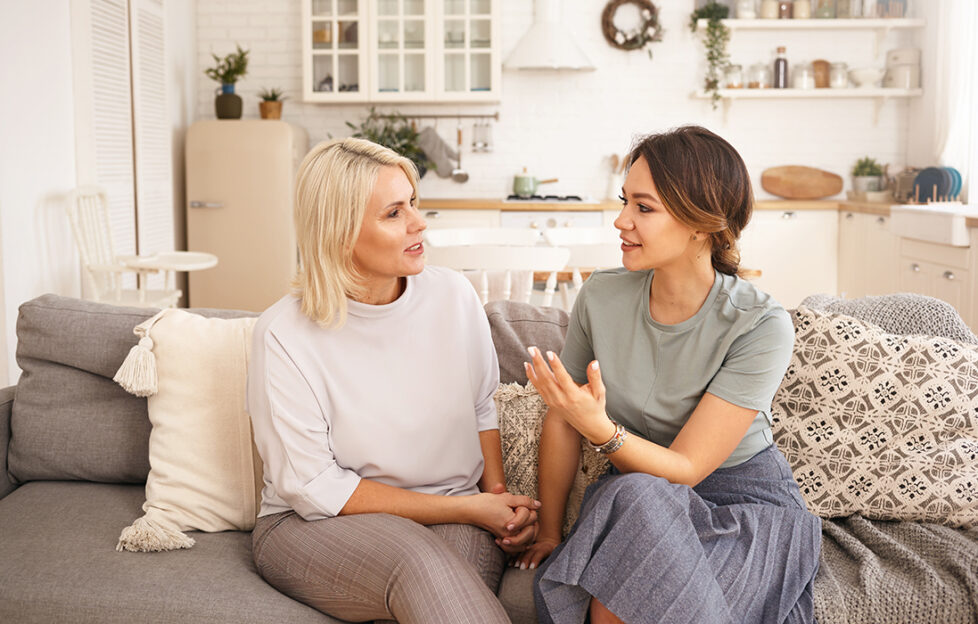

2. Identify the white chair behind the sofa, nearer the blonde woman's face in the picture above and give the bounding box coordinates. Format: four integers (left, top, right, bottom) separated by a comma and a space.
424, 228, 570, 305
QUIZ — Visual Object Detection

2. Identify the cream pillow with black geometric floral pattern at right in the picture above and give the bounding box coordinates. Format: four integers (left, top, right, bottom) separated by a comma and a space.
771, 307, 978, 527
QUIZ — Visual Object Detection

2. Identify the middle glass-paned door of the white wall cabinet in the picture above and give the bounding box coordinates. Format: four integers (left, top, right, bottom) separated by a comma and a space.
371, 0, 432, 100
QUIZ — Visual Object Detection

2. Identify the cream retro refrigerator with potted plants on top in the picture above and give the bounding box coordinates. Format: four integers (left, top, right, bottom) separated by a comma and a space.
186, 119, 309, 312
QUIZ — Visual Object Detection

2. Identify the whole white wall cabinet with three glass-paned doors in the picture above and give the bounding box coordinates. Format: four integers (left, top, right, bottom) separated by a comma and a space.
302, 0, 502, 102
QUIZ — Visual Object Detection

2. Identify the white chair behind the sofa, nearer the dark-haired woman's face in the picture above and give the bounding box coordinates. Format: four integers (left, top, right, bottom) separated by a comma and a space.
543, 227, 621, 310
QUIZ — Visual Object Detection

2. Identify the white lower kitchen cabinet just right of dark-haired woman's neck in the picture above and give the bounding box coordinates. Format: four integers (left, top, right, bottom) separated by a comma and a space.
740, 208, 839, 308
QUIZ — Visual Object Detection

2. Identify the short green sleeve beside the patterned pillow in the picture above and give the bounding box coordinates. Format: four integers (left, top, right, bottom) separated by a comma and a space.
706, 308, 795, 411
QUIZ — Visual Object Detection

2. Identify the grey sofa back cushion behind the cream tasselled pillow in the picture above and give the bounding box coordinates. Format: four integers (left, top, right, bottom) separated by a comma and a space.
8, 295, 255, 483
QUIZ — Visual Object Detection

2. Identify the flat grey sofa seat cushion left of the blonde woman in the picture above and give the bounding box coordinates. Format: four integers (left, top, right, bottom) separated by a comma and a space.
0, 482, 338, 624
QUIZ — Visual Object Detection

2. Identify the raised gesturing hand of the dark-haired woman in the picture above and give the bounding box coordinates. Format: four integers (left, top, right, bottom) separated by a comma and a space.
524, 347, 614, 442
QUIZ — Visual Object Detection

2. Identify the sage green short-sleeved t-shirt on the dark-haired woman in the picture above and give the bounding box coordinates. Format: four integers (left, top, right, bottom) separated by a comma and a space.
560, 268, 794, 468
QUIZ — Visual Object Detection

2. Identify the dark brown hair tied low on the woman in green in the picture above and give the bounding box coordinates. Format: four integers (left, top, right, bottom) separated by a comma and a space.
628, 126, 754, 275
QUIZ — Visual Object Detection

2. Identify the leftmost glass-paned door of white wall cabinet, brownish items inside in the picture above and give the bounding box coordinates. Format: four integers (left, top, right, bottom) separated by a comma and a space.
304, 0, 366, 101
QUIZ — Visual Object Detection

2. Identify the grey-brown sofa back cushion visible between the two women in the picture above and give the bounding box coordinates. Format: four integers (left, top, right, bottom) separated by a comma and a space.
485, 301, 568, 384
